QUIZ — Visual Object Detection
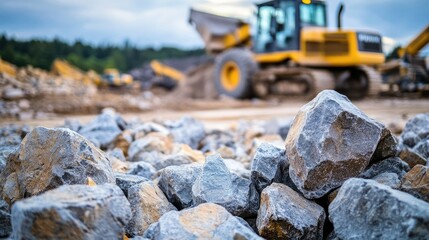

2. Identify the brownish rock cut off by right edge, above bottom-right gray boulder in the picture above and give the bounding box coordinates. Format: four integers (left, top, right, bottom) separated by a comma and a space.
401, 165, 429, 202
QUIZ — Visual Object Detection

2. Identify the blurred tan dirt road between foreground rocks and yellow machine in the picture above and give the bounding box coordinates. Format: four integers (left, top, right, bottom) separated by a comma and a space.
0, 99, 429, 129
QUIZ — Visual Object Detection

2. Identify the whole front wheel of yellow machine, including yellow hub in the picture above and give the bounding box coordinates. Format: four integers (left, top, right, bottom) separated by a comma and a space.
215, 48, 258, 98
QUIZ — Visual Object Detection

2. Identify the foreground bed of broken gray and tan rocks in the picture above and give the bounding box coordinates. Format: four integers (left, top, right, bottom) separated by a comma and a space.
0, 91, 429, 239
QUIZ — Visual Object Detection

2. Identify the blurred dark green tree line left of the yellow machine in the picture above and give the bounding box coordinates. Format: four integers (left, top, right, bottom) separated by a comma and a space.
0, 35, 204, 73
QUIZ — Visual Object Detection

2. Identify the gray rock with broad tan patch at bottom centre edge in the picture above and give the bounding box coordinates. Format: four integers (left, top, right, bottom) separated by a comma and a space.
144, 203, 262, 240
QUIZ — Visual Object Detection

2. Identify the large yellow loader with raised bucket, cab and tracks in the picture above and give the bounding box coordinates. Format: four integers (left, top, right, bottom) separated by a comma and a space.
189, 0, 385, 98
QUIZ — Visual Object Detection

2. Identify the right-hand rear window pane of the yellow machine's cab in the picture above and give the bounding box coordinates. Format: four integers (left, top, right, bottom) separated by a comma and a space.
300, 3, 326, 27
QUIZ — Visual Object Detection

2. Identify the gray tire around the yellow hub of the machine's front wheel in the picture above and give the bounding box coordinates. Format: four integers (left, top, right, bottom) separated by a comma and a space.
214, 48, 258, 98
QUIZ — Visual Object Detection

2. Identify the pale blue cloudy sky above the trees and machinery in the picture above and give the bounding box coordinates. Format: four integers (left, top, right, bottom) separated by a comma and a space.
0, 0, 429, 48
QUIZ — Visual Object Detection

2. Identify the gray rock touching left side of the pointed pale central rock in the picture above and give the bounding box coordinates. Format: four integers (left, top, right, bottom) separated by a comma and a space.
158, 164, 202, 209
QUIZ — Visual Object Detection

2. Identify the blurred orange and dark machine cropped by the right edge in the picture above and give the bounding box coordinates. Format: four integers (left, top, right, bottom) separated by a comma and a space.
380, 25, 429, 94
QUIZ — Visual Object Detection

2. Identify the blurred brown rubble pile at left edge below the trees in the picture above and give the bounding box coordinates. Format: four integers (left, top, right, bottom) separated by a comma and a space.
0, 66, 97, 118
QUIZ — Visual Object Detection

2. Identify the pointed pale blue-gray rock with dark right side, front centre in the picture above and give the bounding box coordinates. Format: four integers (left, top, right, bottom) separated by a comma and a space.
192, 154, 259, 217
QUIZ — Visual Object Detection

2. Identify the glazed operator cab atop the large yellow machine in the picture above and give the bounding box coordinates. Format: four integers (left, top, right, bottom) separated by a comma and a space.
253, 0, 327, 53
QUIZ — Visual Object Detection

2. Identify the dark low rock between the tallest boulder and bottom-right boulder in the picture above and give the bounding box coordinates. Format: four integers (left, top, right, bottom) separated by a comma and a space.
359, 157, 410, 179
